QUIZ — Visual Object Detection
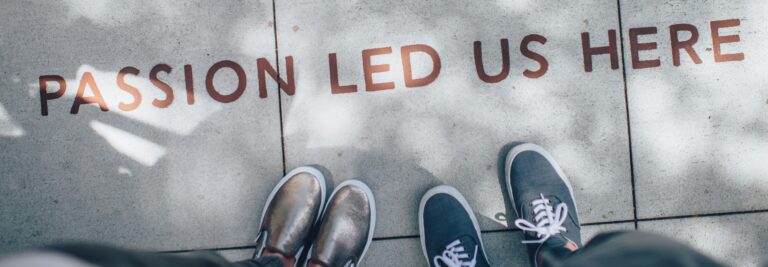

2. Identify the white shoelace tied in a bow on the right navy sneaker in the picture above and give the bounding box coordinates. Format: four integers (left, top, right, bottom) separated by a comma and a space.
515, 194, 568, 244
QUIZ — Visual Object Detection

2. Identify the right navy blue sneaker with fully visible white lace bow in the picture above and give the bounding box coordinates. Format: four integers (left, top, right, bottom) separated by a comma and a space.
505, 144, 581, 267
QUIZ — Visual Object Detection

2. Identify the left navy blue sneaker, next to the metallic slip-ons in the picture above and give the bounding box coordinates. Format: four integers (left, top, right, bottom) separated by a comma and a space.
419, 185, 489, 267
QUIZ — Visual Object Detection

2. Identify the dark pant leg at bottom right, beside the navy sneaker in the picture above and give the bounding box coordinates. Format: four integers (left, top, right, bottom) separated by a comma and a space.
543, 231, 723, 267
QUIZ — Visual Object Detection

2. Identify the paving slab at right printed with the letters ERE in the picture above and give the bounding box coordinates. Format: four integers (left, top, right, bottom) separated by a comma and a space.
621, 0, 768, 218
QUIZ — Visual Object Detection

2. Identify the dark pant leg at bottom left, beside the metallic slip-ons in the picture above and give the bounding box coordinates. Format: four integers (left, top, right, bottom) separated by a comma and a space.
44, 244, 282, 267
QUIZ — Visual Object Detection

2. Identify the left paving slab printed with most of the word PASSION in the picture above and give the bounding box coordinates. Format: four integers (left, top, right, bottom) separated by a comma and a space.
0, 0, 283, 254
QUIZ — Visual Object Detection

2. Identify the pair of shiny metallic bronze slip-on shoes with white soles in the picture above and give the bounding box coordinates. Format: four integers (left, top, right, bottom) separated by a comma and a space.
255, 166, 376, 267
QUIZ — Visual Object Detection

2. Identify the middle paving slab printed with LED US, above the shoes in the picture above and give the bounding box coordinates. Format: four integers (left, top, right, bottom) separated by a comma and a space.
276, 1, 632, 237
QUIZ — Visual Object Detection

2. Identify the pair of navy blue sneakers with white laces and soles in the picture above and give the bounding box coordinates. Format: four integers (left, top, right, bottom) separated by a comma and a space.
419, 144, 581, 267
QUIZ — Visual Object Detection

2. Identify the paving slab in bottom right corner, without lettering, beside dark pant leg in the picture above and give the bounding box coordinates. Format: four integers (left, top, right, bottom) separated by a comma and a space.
638, 213, 768, 267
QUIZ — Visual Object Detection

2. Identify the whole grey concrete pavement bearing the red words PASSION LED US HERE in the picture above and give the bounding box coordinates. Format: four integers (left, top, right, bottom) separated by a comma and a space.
0, 0, 768, 266
